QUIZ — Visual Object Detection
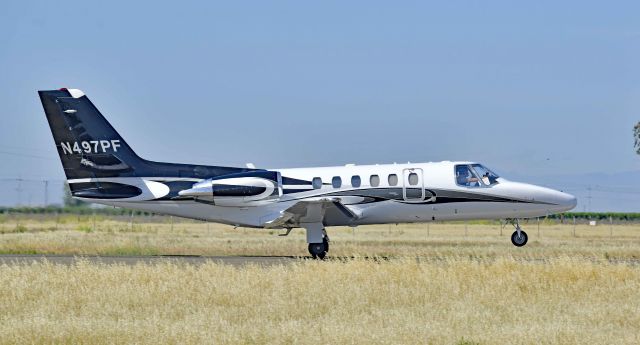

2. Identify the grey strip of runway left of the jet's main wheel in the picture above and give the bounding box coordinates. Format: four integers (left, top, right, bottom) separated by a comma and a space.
0, 254, 304, 266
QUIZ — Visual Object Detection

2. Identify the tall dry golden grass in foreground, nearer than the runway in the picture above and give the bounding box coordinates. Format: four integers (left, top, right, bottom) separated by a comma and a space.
0, 257, 640, 344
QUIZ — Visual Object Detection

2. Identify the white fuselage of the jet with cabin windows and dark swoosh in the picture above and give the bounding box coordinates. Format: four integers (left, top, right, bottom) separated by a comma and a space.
82, 162, 576, 227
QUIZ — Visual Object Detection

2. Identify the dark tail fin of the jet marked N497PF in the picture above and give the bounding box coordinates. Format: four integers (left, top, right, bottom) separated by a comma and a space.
38, 89, 252, 180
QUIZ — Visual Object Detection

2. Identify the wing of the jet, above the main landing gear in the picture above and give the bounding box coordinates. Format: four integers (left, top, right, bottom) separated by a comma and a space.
264, 198, 360, 228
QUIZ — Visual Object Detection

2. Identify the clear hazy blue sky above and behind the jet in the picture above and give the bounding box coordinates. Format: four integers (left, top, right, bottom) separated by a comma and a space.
0, 1, 640, 210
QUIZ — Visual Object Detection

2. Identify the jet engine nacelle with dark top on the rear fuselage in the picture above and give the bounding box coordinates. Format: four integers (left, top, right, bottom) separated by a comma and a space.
178, 170, 282, 206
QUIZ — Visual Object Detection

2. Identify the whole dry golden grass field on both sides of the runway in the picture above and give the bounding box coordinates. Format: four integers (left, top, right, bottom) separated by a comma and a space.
0, 217, 640, 344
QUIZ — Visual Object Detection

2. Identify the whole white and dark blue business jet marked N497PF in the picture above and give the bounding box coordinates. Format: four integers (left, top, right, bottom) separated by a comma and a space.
38, 88, 576, 259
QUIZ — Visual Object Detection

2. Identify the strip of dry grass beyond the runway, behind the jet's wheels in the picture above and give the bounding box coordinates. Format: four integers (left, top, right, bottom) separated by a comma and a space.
0, 216, 640, 260
